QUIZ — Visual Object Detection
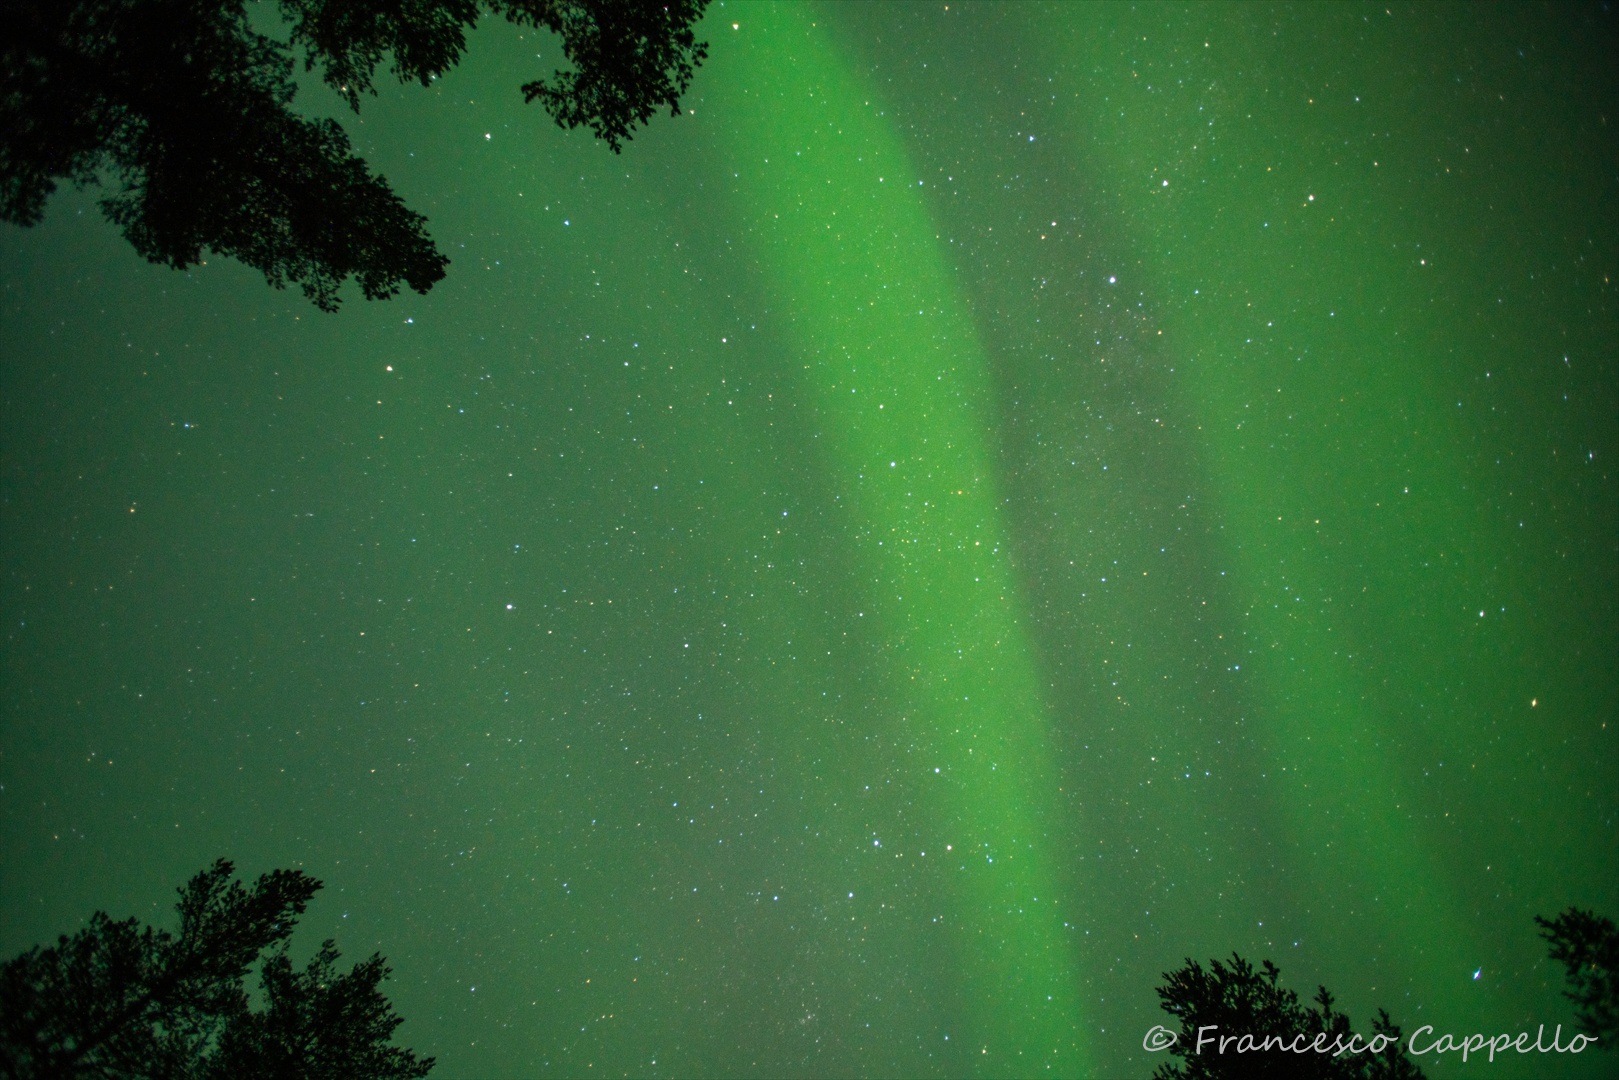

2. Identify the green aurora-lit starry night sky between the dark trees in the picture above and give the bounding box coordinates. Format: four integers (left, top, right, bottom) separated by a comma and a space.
0, 0, 1619, 1077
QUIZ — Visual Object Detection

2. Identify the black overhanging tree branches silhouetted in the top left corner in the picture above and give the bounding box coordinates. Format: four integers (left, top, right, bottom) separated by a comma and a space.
0, 0, 708, 311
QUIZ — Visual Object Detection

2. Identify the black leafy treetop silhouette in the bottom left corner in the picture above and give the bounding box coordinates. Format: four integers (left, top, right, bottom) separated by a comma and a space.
0, 860, 434, 1080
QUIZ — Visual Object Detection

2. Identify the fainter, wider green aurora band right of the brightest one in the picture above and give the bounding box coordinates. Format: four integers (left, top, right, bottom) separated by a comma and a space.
1031, 0, 1507, 1028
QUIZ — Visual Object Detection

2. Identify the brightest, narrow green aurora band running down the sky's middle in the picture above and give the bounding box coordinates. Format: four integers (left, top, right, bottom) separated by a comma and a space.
706, 6, 1091, 1075
